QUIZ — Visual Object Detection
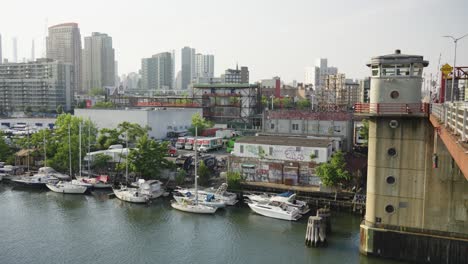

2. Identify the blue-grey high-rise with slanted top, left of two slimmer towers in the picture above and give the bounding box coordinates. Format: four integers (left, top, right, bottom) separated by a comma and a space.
141, 52, 174, 91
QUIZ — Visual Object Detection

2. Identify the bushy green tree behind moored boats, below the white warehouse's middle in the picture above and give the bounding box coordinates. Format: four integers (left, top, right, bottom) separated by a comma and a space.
124, 134, 173, 179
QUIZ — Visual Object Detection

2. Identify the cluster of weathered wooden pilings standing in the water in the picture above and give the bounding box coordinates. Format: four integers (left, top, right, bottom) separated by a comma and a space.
305, 208, 331, 247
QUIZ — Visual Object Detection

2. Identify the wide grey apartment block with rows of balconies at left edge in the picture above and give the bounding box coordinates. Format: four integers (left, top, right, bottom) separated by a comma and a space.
0, 59, 73, 113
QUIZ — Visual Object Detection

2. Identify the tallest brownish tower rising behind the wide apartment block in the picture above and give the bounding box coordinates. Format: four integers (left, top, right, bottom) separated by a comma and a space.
46, 23, 83, 93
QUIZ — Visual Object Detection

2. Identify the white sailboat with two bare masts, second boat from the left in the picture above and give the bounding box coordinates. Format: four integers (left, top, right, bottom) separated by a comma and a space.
44, 123, 91, 194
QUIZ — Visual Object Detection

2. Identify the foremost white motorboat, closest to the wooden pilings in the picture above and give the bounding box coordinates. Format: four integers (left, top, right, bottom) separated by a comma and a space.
248, 201, 302, 221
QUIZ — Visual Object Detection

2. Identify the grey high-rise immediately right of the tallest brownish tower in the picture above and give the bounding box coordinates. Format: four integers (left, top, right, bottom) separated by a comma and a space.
82, 32, 115, 93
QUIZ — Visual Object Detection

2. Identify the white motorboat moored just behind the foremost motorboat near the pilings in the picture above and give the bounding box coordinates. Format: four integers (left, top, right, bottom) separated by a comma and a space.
244, 192, 310, 214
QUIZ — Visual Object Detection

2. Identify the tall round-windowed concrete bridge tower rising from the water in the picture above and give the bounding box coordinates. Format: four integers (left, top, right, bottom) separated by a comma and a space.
355, 50, 468, 263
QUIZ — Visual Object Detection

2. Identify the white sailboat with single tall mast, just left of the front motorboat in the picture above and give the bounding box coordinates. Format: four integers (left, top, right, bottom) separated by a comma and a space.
171, 127, 218, 214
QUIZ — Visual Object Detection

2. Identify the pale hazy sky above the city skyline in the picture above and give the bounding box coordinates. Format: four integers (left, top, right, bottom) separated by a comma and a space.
0, 0, 468, 82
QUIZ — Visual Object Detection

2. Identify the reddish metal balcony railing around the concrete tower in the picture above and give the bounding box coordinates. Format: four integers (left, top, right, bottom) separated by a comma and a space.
354, 103, 429, 114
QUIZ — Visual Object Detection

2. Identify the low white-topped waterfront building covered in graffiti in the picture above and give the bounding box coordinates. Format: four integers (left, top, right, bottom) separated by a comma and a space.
230, 136, 333, 186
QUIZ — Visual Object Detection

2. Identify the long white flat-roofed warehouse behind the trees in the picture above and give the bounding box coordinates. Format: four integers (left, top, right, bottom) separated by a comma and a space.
75, 108, 202, 139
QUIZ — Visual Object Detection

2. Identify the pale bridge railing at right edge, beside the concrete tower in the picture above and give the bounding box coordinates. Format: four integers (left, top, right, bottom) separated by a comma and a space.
431, 102, 468, 141
